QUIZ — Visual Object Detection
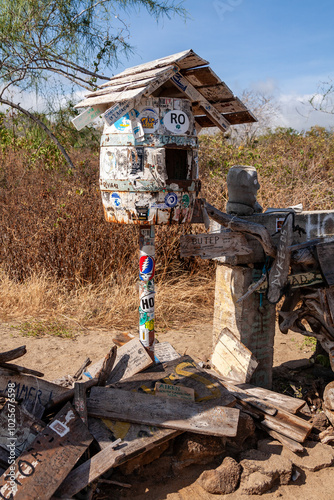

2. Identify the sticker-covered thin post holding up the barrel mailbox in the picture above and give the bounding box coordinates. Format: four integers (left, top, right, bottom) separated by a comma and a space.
139, 225, 155, 360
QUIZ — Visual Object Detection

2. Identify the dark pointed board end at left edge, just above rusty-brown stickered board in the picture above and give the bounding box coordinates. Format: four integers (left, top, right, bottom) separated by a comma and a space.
0, 401, 45, 457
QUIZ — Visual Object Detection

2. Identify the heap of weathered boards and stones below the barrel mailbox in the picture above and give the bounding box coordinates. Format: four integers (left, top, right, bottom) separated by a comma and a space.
0, 339, 334, 500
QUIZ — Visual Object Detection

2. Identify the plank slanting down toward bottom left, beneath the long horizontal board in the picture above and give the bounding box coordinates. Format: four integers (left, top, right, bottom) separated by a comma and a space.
56, 425, 180, 498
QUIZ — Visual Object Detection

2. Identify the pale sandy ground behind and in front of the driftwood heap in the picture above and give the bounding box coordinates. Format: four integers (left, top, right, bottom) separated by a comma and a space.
0, 318, 334, 500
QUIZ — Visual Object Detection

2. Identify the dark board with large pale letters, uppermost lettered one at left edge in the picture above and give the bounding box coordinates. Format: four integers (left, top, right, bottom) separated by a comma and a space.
0, 368, 68, 405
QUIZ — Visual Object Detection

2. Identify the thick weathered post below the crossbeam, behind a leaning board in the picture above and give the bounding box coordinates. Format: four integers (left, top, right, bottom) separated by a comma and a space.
213, 263, 276, 389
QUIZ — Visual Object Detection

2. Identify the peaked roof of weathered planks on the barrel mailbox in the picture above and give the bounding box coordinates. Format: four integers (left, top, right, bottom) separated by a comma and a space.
75, 50, 257, 130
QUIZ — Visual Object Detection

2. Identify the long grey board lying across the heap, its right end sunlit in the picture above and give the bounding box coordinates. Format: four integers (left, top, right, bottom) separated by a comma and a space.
87, 387, 239, 437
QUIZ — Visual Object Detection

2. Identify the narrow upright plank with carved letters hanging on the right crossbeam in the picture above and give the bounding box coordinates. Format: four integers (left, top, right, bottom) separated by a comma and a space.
267, 214, 294, 304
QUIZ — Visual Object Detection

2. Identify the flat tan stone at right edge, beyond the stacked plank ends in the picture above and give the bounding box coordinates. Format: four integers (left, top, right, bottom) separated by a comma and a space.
282, 441, 334, 471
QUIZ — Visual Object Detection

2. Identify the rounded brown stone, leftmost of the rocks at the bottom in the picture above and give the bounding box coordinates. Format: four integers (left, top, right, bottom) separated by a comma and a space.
198, 457, 241, 495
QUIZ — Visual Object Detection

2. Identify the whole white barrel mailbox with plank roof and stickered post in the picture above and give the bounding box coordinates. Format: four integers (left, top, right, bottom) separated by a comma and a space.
73, 50, 256, 357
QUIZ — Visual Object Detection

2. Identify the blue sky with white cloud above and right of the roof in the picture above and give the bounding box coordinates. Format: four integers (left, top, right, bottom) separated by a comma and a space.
108, 0, 334, 129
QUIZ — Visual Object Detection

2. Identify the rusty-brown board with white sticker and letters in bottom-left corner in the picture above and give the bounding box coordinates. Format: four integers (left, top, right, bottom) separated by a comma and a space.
0, 403, 93, 500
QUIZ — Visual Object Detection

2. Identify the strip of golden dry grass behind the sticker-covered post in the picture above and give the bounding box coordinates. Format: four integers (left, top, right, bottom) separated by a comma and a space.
0, 272, 214, 330
